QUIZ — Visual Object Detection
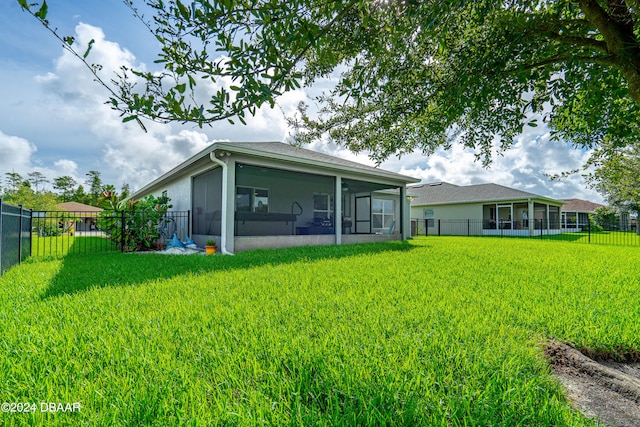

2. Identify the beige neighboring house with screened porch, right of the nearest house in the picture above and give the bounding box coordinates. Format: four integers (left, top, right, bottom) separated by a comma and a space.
407, 182, 564, 236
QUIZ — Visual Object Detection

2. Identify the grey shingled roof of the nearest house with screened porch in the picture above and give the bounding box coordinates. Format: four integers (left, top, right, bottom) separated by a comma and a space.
132, 142, 419, 198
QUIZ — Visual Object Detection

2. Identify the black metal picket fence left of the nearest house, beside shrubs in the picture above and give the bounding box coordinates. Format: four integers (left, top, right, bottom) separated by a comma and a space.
31, 211, 191, 257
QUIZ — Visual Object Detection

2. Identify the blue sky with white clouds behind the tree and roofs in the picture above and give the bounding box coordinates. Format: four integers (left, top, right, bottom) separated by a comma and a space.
0, 0, 602, 202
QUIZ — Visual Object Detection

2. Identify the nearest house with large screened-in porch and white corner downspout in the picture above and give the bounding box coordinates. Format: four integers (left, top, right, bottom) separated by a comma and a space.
131, 142, 419, 253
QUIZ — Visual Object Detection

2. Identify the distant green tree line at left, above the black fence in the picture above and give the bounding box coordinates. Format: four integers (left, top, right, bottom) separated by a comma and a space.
0, 170, 130, 211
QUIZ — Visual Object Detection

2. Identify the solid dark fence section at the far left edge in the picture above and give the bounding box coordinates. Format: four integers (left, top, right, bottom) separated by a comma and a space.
0, 200, 31, 276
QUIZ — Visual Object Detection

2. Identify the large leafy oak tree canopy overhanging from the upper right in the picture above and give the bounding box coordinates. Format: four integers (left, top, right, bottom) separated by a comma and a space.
17, 0, 640, 162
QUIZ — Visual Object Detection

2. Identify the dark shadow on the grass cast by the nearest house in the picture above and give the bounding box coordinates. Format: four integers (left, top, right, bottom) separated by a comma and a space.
41, 241, 414, 300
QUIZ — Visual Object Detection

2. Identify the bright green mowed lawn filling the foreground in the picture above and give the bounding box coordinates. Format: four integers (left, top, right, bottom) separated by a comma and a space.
0, 237, 640, 426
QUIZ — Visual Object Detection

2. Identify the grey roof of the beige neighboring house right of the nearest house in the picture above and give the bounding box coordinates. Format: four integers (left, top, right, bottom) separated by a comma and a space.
407, 182, 563, 206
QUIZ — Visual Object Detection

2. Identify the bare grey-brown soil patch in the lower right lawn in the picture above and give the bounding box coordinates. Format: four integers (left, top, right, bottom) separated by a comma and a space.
545, 342, 640, 427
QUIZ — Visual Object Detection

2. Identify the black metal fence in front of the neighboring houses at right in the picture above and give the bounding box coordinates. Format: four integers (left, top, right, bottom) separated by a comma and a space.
411, 219, 640, 246
